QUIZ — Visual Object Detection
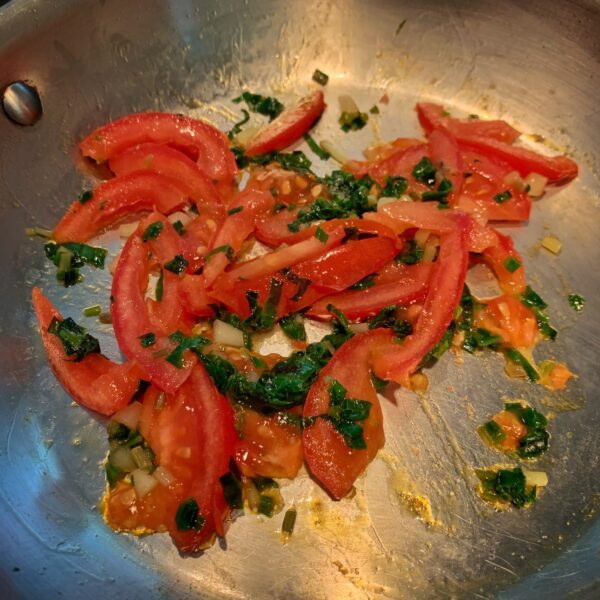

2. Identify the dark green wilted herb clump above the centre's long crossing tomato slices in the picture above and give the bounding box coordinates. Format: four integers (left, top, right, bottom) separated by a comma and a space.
288, 170, 376, 232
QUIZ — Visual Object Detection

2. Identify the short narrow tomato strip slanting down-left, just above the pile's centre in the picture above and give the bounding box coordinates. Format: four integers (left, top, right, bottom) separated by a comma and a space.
203, 190, 275, 287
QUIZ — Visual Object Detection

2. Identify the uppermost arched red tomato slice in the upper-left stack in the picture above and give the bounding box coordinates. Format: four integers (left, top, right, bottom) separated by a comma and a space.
79, 112, 237, 183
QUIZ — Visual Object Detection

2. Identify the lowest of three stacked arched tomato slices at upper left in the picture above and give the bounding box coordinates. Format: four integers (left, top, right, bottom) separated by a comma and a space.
52, 171, 188, 244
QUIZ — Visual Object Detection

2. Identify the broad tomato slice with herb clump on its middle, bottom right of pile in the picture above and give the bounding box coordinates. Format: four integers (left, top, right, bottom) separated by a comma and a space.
302, 329, 393, 500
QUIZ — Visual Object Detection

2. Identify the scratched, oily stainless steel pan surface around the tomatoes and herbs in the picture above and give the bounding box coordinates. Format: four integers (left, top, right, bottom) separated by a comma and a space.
0, 0, 600, 600
